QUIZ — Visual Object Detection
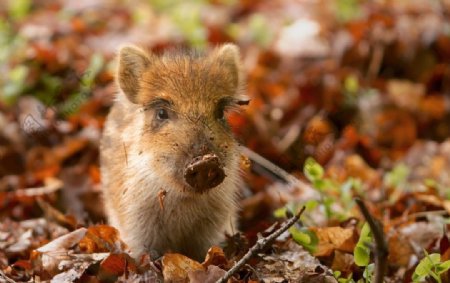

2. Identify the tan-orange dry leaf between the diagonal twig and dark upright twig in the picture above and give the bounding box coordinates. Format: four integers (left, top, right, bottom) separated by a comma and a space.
310, 227, 358, 256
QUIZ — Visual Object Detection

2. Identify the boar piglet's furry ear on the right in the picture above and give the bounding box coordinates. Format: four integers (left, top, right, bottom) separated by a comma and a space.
217, 43, 242, 93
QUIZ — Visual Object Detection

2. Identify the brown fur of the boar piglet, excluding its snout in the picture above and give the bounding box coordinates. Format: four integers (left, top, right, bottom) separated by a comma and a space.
101, 44, 246, 259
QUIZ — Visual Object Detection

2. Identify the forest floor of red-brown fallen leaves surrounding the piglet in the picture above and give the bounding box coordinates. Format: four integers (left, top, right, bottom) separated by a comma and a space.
0, 0, 450, 282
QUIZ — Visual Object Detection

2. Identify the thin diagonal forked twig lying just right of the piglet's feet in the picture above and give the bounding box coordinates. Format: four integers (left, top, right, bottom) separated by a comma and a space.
216, 207, 305, 283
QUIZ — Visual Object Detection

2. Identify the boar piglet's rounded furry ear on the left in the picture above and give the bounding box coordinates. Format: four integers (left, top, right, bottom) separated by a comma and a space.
117, 46, 152, 103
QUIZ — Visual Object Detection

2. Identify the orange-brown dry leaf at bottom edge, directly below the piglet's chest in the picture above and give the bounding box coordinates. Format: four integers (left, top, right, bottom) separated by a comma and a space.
162, 253, 204, 283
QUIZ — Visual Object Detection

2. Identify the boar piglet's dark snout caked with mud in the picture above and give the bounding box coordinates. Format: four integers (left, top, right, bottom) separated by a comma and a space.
184, 154, 225, 193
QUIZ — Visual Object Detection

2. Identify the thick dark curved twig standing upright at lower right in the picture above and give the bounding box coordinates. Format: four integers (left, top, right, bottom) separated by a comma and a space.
355, 198, 389, 283
